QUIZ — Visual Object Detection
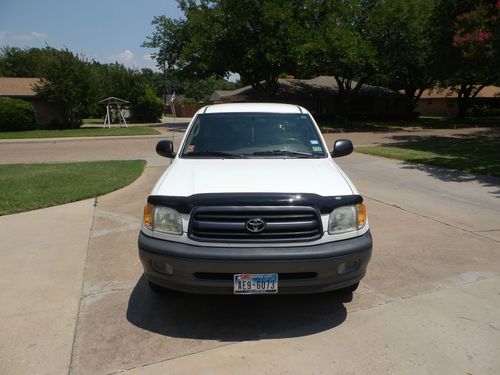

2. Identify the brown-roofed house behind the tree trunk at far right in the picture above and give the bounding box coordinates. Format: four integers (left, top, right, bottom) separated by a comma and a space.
415, 86, 500, 117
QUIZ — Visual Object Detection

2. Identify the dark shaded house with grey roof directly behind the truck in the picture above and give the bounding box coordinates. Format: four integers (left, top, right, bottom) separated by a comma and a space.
210, 76, 405, 118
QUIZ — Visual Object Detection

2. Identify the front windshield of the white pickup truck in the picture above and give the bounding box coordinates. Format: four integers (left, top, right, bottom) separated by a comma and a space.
181, 113, 327, 158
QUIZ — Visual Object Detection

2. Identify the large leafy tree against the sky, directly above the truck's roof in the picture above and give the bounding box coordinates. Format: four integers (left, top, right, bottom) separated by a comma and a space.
143, 0, 303, 96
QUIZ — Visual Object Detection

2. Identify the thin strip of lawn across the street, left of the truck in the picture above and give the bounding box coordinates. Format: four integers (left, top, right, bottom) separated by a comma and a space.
0, 126, 160, 139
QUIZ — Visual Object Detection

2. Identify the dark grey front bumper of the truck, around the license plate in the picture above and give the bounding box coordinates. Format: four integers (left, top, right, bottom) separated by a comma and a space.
139, 231, 372, 294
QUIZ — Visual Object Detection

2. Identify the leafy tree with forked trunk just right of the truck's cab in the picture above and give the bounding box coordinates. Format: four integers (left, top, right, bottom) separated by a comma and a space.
300, 0, 379, 122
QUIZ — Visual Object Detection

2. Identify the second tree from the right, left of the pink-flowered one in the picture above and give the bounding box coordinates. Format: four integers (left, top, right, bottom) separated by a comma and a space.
371, 0, 439, 118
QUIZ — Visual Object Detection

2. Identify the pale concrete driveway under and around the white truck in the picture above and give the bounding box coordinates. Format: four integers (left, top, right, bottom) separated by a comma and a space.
0, 128, 500, 374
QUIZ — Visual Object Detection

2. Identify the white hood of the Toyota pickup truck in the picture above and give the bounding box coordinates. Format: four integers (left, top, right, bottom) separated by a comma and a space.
151, 158, 357, 197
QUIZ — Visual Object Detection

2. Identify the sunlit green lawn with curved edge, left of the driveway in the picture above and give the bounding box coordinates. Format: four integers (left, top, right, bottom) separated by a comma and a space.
0, 160, 146, 215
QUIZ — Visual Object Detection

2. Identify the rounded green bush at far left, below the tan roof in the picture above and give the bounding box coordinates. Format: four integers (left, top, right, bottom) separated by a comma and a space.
0, 98, 36, 132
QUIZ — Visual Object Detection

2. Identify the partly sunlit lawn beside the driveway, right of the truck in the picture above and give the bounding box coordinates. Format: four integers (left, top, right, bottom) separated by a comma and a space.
356, 137, 500, 177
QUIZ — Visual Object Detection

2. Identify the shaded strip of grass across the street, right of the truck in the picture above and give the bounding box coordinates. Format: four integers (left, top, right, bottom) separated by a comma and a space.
318, 116, 500, 133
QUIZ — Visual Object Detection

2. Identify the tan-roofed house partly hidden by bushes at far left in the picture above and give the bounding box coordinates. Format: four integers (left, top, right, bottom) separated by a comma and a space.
0, 77, 64, 128
